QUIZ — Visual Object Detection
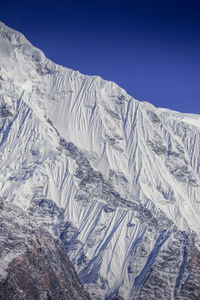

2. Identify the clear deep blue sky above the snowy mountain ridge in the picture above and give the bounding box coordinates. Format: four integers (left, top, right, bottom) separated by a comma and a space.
0, 0, 200, 114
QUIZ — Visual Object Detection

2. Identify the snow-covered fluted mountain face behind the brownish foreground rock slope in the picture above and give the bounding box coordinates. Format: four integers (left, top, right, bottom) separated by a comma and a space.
0, 23, 200, 300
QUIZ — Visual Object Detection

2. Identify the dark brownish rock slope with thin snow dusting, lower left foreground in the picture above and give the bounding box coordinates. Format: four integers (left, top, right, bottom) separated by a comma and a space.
0, 201, 90, 300
